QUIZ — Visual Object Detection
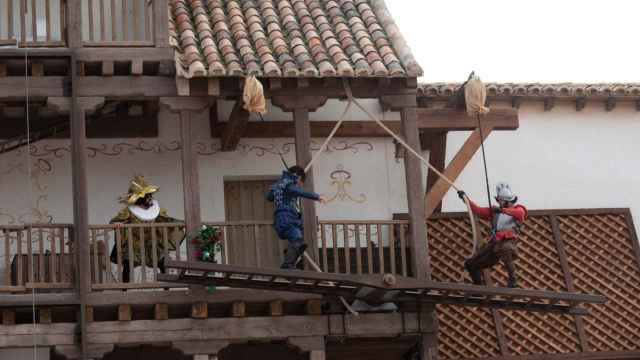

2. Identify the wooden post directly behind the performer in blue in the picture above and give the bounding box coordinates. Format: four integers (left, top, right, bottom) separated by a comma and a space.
293, 109, 318, 261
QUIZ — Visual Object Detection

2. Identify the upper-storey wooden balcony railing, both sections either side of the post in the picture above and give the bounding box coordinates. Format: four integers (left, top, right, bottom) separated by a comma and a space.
0, 0, 168, 48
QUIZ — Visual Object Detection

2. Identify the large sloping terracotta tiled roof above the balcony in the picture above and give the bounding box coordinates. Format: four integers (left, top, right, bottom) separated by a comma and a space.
169, 0, 422, 78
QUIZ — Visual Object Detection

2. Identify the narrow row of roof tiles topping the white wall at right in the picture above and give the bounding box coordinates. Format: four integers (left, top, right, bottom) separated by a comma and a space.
418, 83, 640, 99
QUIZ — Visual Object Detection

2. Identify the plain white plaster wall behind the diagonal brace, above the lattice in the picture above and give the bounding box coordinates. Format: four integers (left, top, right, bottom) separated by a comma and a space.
444, 102, 640, 229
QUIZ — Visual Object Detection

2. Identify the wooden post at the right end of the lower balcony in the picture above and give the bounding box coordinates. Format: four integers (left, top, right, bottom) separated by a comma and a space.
400, 107, 431, 280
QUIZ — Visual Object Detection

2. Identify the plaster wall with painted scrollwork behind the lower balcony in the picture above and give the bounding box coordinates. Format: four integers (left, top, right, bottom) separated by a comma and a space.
0, 101, 406, 224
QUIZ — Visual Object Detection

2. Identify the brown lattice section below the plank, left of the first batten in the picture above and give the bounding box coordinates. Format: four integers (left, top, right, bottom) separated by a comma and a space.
438, 305, 500, 359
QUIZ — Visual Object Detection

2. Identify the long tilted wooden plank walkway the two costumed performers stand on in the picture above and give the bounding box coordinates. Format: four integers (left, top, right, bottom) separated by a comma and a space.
158, 261, 607, 315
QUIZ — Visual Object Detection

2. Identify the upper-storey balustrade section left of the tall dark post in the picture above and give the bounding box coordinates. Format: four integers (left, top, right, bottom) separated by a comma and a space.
0, 0, 66, 47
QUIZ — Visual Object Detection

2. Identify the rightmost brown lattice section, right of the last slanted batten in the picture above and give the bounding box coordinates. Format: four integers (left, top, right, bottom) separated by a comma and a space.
558, 214, 640, 351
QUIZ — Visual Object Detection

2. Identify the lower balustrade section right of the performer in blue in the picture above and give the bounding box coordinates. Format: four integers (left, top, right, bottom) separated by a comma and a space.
318, 221, 411, 276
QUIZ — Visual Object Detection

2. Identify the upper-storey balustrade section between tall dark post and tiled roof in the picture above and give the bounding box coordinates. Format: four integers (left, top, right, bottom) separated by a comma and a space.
82, 0, 154, 46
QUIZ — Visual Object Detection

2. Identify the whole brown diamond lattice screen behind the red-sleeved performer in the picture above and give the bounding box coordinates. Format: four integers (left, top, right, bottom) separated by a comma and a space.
428, 209, 640, 359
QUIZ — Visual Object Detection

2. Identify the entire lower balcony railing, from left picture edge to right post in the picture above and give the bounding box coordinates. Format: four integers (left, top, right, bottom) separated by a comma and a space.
0, 221, 411, 293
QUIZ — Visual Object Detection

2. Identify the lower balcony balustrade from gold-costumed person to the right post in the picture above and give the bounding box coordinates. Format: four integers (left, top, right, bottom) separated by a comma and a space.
89, 221, 411, 290
